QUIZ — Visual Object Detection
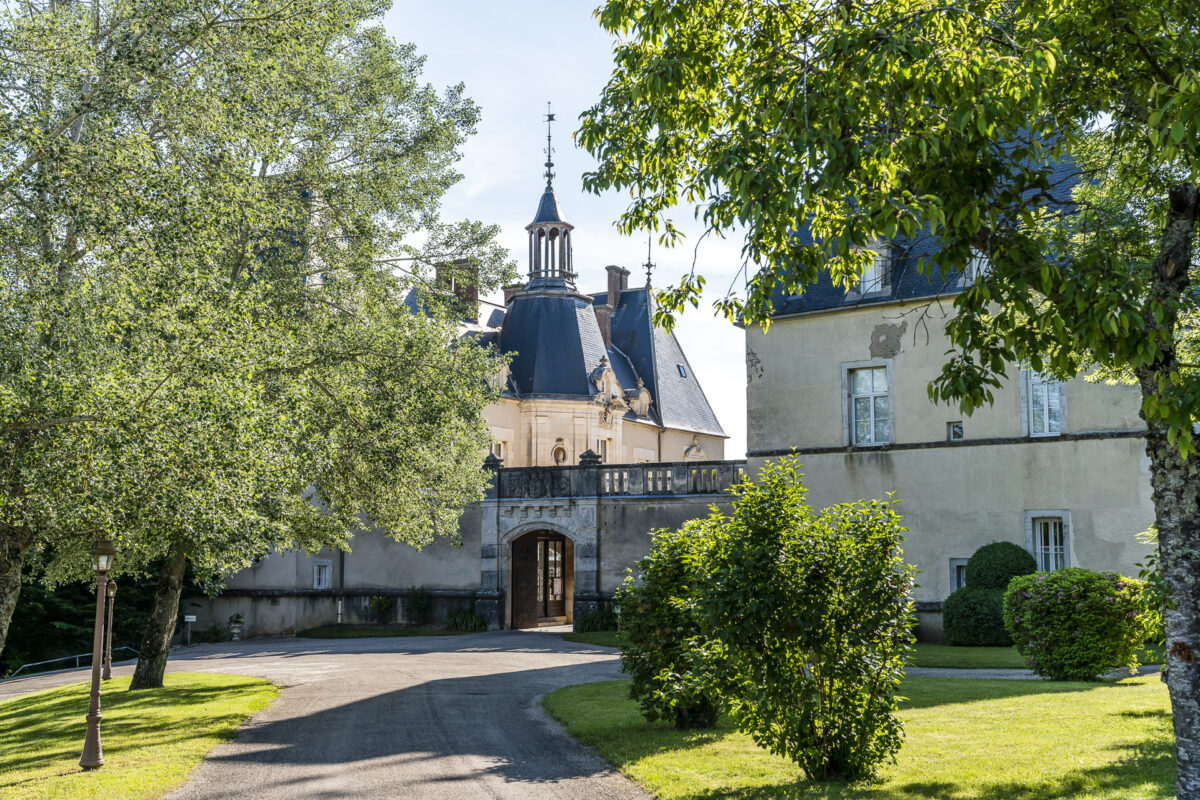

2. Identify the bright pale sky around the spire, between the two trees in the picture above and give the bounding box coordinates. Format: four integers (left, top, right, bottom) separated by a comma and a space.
383, 0, 746, 458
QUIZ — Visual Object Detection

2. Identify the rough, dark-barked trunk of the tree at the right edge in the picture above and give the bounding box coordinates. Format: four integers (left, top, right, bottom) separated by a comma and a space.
1138, 186, 1200, 800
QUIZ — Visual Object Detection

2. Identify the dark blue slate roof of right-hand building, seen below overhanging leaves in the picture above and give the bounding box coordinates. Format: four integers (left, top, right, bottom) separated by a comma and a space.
773, 160, 1079, 317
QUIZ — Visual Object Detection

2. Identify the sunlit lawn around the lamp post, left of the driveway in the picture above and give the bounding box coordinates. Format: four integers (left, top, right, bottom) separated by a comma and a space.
0, 673, 278, 800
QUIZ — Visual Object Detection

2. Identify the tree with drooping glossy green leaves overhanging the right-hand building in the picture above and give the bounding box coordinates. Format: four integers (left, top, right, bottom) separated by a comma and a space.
578, 0, 1200, 786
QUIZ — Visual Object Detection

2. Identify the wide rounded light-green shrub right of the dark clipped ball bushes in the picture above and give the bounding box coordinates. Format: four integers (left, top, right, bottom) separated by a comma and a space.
1004, 567, 1147, 680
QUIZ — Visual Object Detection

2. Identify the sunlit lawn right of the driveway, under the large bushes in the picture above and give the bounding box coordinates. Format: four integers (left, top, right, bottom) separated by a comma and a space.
545, 676, 1175, 800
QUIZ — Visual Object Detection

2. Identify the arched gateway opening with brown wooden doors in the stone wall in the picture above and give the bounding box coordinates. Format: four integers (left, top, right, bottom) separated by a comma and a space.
512, 530, 571, 627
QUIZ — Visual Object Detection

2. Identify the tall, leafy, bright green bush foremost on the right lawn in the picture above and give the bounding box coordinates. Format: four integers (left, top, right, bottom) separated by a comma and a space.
700, 457, 914, 778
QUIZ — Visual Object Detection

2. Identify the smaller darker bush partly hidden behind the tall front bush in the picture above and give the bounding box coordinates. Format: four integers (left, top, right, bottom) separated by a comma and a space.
614, 521, 720, 728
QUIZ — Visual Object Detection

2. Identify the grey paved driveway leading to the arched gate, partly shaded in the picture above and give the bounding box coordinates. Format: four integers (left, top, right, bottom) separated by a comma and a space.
0, 631, 649, 800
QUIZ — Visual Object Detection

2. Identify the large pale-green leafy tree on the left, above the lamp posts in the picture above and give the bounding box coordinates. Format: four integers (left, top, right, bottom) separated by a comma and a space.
0, 0, 511, 685
